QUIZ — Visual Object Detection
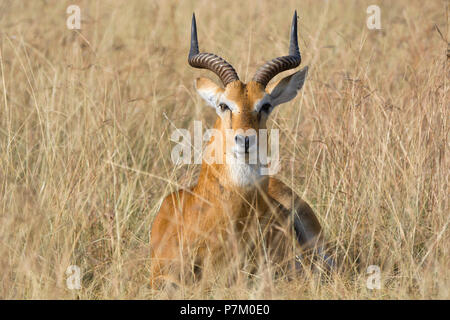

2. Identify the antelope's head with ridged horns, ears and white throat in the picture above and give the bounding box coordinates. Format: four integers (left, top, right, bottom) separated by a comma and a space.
188, 12, 308, 187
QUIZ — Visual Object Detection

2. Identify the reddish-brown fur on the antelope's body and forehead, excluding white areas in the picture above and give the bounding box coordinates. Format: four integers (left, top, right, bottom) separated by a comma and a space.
151, 80, 321, 286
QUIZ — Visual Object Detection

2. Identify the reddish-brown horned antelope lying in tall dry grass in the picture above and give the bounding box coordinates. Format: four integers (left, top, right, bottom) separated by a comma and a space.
150, 11, 334, 287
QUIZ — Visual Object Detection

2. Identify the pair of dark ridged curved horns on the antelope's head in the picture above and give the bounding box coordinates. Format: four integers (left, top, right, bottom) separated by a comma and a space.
188, 11, 302, 87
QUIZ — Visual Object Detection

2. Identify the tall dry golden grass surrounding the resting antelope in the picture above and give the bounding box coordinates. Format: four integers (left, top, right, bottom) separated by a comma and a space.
0, 0, 450, 299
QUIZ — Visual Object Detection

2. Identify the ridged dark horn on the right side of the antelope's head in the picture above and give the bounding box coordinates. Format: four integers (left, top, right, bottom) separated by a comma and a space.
253, 10, 302, 87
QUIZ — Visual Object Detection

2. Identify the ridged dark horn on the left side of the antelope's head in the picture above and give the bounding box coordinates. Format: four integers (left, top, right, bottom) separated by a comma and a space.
188, 14, 239, 86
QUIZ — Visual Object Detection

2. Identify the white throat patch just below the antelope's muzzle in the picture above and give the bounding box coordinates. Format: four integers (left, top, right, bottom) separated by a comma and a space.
228, 156, 261, 188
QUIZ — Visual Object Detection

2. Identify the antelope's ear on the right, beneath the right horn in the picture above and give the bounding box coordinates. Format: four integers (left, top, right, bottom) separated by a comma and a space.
267, 66, 308, 107
